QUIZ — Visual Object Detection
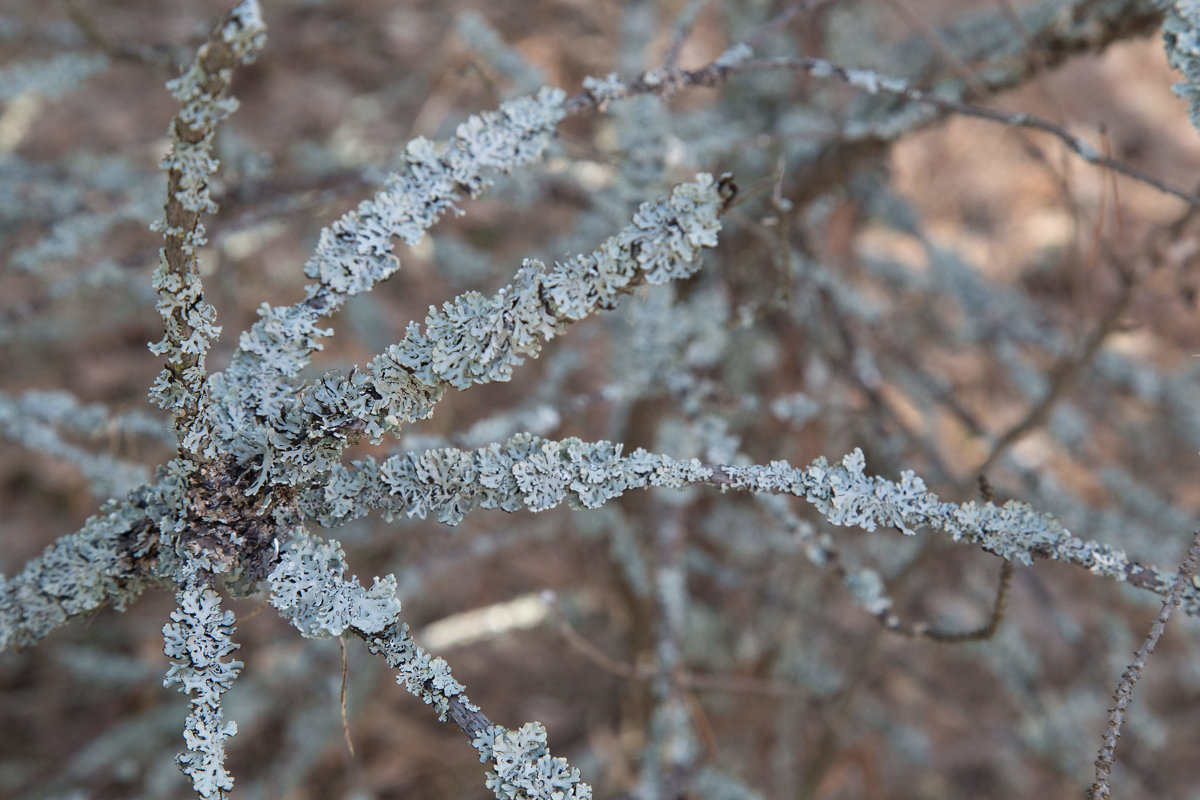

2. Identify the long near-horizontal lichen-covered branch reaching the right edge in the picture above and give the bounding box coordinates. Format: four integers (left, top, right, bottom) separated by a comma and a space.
304, 434, 1200, 614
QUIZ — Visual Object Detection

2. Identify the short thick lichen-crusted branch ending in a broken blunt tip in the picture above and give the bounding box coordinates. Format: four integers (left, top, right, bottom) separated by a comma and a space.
226, 174, 725, 485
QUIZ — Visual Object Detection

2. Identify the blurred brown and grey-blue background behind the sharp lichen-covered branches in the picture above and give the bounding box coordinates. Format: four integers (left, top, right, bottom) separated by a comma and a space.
0, 0, 1200, 800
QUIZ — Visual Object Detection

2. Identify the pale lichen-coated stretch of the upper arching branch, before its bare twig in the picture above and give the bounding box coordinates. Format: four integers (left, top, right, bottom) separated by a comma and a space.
195, 89, 564, 479
